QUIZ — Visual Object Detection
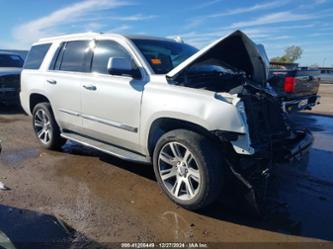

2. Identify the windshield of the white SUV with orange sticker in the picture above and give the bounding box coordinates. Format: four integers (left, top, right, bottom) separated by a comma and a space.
132, 39, 198, 74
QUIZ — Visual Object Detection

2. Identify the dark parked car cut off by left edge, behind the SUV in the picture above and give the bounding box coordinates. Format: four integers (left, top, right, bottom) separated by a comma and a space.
0, 52, 24, 105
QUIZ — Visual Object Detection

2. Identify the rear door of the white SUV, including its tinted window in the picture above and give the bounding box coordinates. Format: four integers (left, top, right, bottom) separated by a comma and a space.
46, 40, 92, 132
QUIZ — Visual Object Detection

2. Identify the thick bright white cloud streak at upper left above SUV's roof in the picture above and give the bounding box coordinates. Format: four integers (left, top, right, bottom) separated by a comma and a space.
13, 0, 129, 46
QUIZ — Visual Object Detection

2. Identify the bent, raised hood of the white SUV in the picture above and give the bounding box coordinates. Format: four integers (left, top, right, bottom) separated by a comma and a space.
167, 30, 269, 85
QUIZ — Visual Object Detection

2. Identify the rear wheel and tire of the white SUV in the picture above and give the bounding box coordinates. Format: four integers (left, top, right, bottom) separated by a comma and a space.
32, 102, 66, 150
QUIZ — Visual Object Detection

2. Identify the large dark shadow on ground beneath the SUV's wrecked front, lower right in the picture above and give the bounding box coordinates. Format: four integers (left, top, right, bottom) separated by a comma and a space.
199, 146, 333, 241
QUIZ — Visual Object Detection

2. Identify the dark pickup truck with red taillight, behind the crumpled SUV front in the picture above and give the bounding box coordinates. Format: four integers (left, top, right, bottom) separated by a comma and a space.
268, 63, 320, 112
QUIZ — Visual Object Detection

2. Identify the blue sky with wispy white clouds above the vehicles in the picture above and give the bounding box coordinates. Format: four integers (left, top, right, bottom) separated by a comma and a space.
0, 0, 333, 66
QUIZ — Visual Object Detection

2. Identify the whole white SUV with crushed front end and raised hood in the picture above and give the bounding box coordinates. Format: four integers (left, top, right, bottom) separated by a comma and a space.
20, 31, 312, 209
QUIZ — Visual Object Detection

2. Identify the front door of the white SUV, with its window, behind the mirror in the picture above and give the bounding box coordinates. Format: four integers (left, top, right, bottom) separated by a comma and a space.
81, 40, 147, 150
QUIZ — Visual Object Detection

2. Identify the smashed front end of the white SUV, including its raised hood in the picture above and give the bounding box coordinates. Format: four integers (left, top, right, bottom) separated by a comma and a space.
167, 31, 313, 208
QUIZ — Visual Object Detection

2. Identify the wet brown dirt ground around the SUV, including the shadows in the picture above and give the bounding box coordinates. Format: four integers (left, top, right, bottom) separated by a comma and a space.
0, 85, 333, 248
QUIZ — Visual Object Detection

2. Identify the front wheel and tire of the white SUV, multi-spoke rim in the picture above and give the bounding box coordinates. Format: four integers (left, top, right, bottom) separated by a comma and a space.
153, 129, 224, 210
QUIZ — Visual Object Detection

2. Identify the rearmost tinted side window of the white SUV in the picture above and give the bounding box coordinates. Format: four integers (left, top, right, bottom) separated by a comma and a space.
24, 44, 51, 69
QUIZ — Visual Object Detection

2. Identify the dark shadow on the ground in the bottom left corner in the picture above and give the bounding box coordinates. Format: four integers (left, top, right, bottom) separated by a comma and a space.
0, 205, 106, 249
